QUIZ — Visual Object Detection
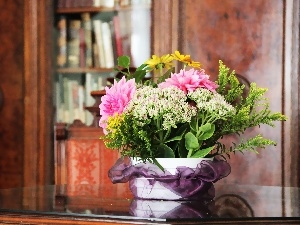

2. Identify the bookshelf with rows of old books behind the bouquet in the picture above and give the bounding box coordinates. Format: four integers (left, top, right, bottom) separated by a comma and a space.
53, 0, 152, 126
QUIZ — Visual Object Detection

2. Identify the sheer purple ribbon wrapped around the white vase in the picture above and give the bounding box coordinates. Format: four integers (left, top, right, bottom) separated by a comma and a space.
108, 157, 230, 199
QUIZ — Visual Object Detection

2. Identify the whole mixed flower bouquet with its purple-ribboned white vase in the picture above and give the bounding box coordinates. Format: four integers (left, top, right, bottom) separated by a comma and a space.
99, 51, 286, 199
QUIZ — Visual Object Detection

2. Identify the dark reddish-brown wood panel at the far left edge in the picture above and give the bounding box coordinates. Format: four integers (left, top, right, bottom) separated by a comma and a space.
0, 0, 24, 188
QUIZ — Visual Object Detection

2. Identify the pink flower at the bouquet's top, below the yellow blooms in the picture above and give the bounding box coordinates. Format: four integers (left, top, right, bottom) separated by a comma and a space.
158, 69, 218, 94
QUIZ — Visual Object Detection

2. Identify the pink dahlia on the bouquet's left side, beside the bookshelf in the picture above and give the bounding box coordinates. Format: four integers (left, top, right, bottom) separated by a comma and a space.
99, 77, 136, 131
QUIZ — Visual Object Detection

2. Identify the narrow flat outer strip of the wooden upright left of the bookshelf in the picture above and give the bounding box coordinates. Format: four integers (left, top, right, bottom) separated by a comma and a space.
24, 0, 39, 188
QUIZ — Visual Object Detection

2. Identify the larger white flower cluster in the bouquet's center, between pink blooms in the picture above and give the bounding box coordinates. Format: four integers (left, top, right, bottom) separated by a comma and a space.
126, 86, 197, 130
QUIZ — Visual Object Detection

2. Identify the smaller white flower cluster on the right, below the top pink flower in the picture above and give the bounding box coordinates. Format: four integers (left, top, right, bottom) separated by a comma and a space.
188, 88, 235, 119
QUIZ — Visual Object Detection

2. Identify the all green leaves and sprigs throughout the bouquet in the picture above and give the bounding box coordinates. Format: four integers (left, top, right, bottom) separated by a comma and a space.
102, 56, 287, 163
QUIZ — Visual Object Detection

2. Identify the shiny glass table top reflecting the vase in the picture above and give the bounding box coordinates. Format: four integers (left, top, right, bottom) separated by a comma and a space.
0, 184, 300, 222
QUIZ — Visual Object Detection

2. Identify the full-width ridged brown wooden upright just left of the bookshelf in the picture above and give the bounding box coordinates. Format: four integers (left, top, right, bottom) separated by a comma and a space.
23, 0, 53, 186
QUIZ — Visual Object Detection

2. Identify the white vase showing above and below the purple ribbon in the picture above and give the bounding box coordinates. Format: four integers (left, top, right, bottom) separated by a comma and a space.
130, 158, 212, 200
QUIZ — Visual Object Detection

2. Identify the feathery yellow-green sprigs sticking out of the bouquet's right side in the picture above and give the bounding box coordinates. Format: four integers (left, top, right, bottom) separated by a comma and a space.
209, 61, 287, 156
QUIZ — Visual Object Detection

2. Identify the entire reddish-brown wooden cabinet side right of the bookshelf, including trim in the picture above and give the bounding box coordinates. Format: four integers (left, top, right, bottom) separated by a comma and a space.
153, 0, 300, 186
